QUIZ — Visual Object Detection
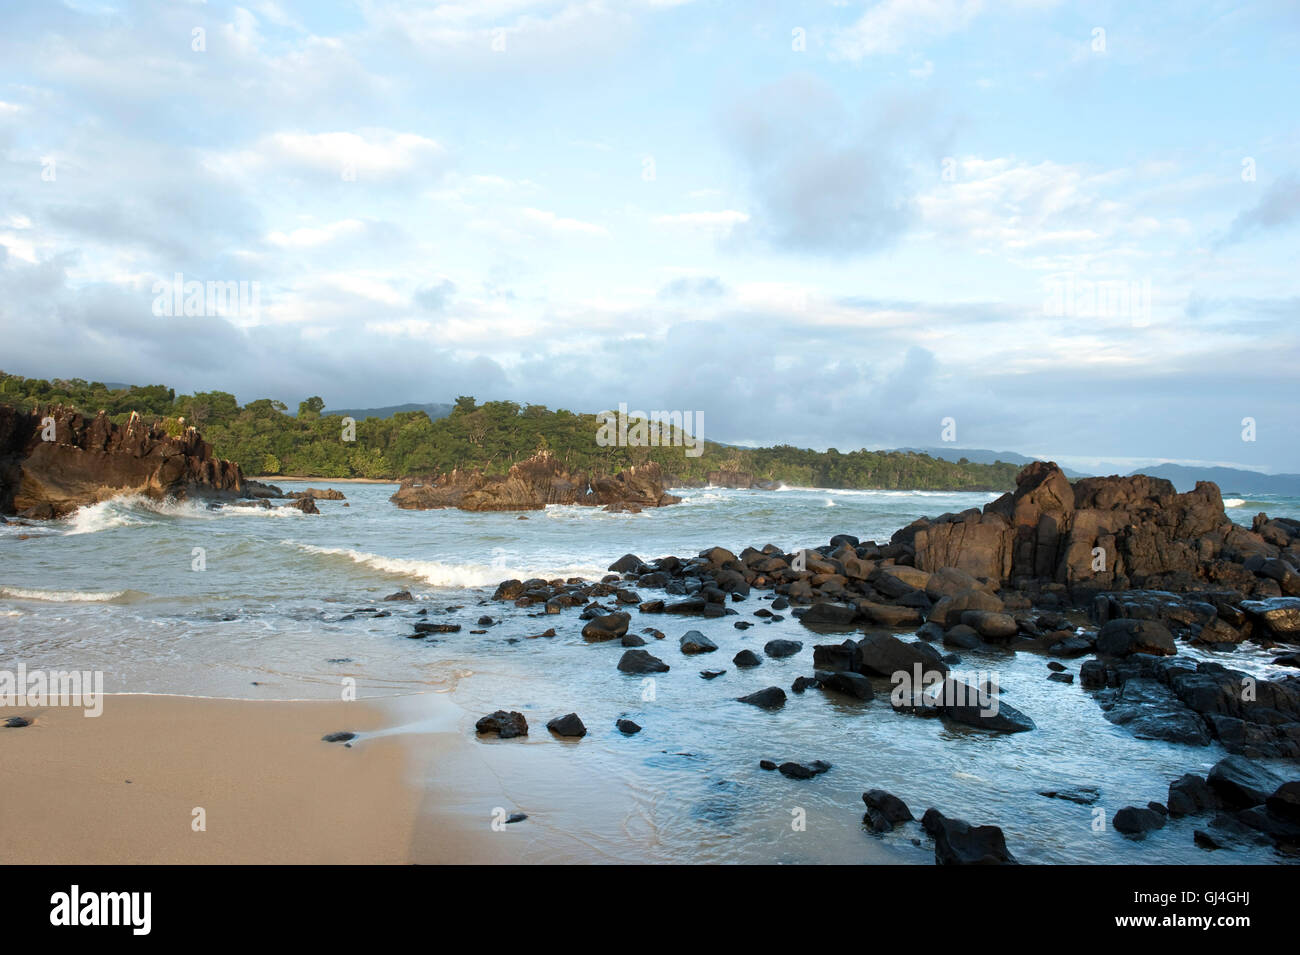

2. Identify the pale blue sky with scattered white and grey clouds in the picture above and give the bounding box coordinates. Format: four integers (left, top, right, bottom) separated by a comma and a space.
0, 0, 1300, 472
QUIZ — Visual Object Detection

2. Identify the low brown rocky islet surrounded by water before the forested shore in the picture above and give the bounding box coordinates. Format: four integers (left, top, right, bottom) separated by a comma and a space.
390, 451, 681, 511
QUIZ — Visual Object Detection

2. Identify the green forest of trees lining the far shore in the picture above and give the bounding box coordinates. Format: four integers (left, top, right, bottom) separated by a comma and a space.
0, 372, 1019, 491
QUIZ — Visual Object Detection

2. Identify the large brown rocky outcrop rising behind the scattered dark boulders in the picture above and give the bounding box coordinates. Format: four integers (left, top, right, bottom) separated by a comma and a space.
892, 461, 1284, 595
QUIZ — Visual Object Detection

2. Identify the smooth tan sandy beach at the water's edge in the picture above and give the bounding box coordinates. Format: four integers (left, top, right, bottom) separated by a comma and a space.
0, 695, 441, 864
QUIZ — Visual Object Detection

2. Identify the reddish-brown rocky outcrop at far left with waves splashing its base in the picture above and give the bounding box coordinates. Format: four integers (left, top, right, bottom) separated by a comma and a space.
0, 405, 244, 518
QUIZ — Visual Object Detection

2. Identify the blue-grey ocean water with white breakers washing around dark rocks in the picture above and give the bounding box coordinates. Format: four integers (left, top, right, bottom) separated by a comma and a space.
0, 481, 1300, 864
